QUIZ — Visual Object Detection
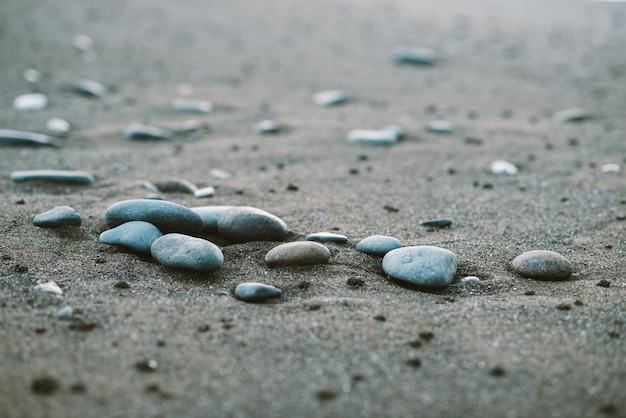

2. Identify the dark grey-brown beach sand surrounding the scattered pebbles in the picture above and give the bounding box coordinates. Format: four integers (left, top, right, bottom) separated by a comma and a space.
0, 0, 626, 418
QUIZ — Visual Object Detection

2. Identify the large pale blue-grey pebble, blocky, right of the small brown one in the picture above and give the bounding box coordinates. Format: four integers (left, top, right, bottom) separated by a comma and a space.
383, 245, 457, 288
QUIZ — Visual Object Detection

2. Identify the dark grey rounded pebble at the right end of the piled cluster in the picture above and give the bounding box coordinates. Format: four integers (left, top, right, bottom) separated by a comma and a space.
217, 206, 289, 242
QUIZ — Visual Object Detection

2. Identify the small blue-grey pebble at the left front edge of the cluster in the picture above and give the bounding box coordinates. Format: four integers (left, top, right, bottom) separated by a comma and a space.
100, 221, 163, 254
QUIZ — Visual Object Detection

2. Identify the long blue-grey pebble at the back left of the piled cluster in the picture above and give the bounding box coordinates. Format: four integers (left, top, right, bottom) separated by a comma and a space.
104, 199, 204, 234
